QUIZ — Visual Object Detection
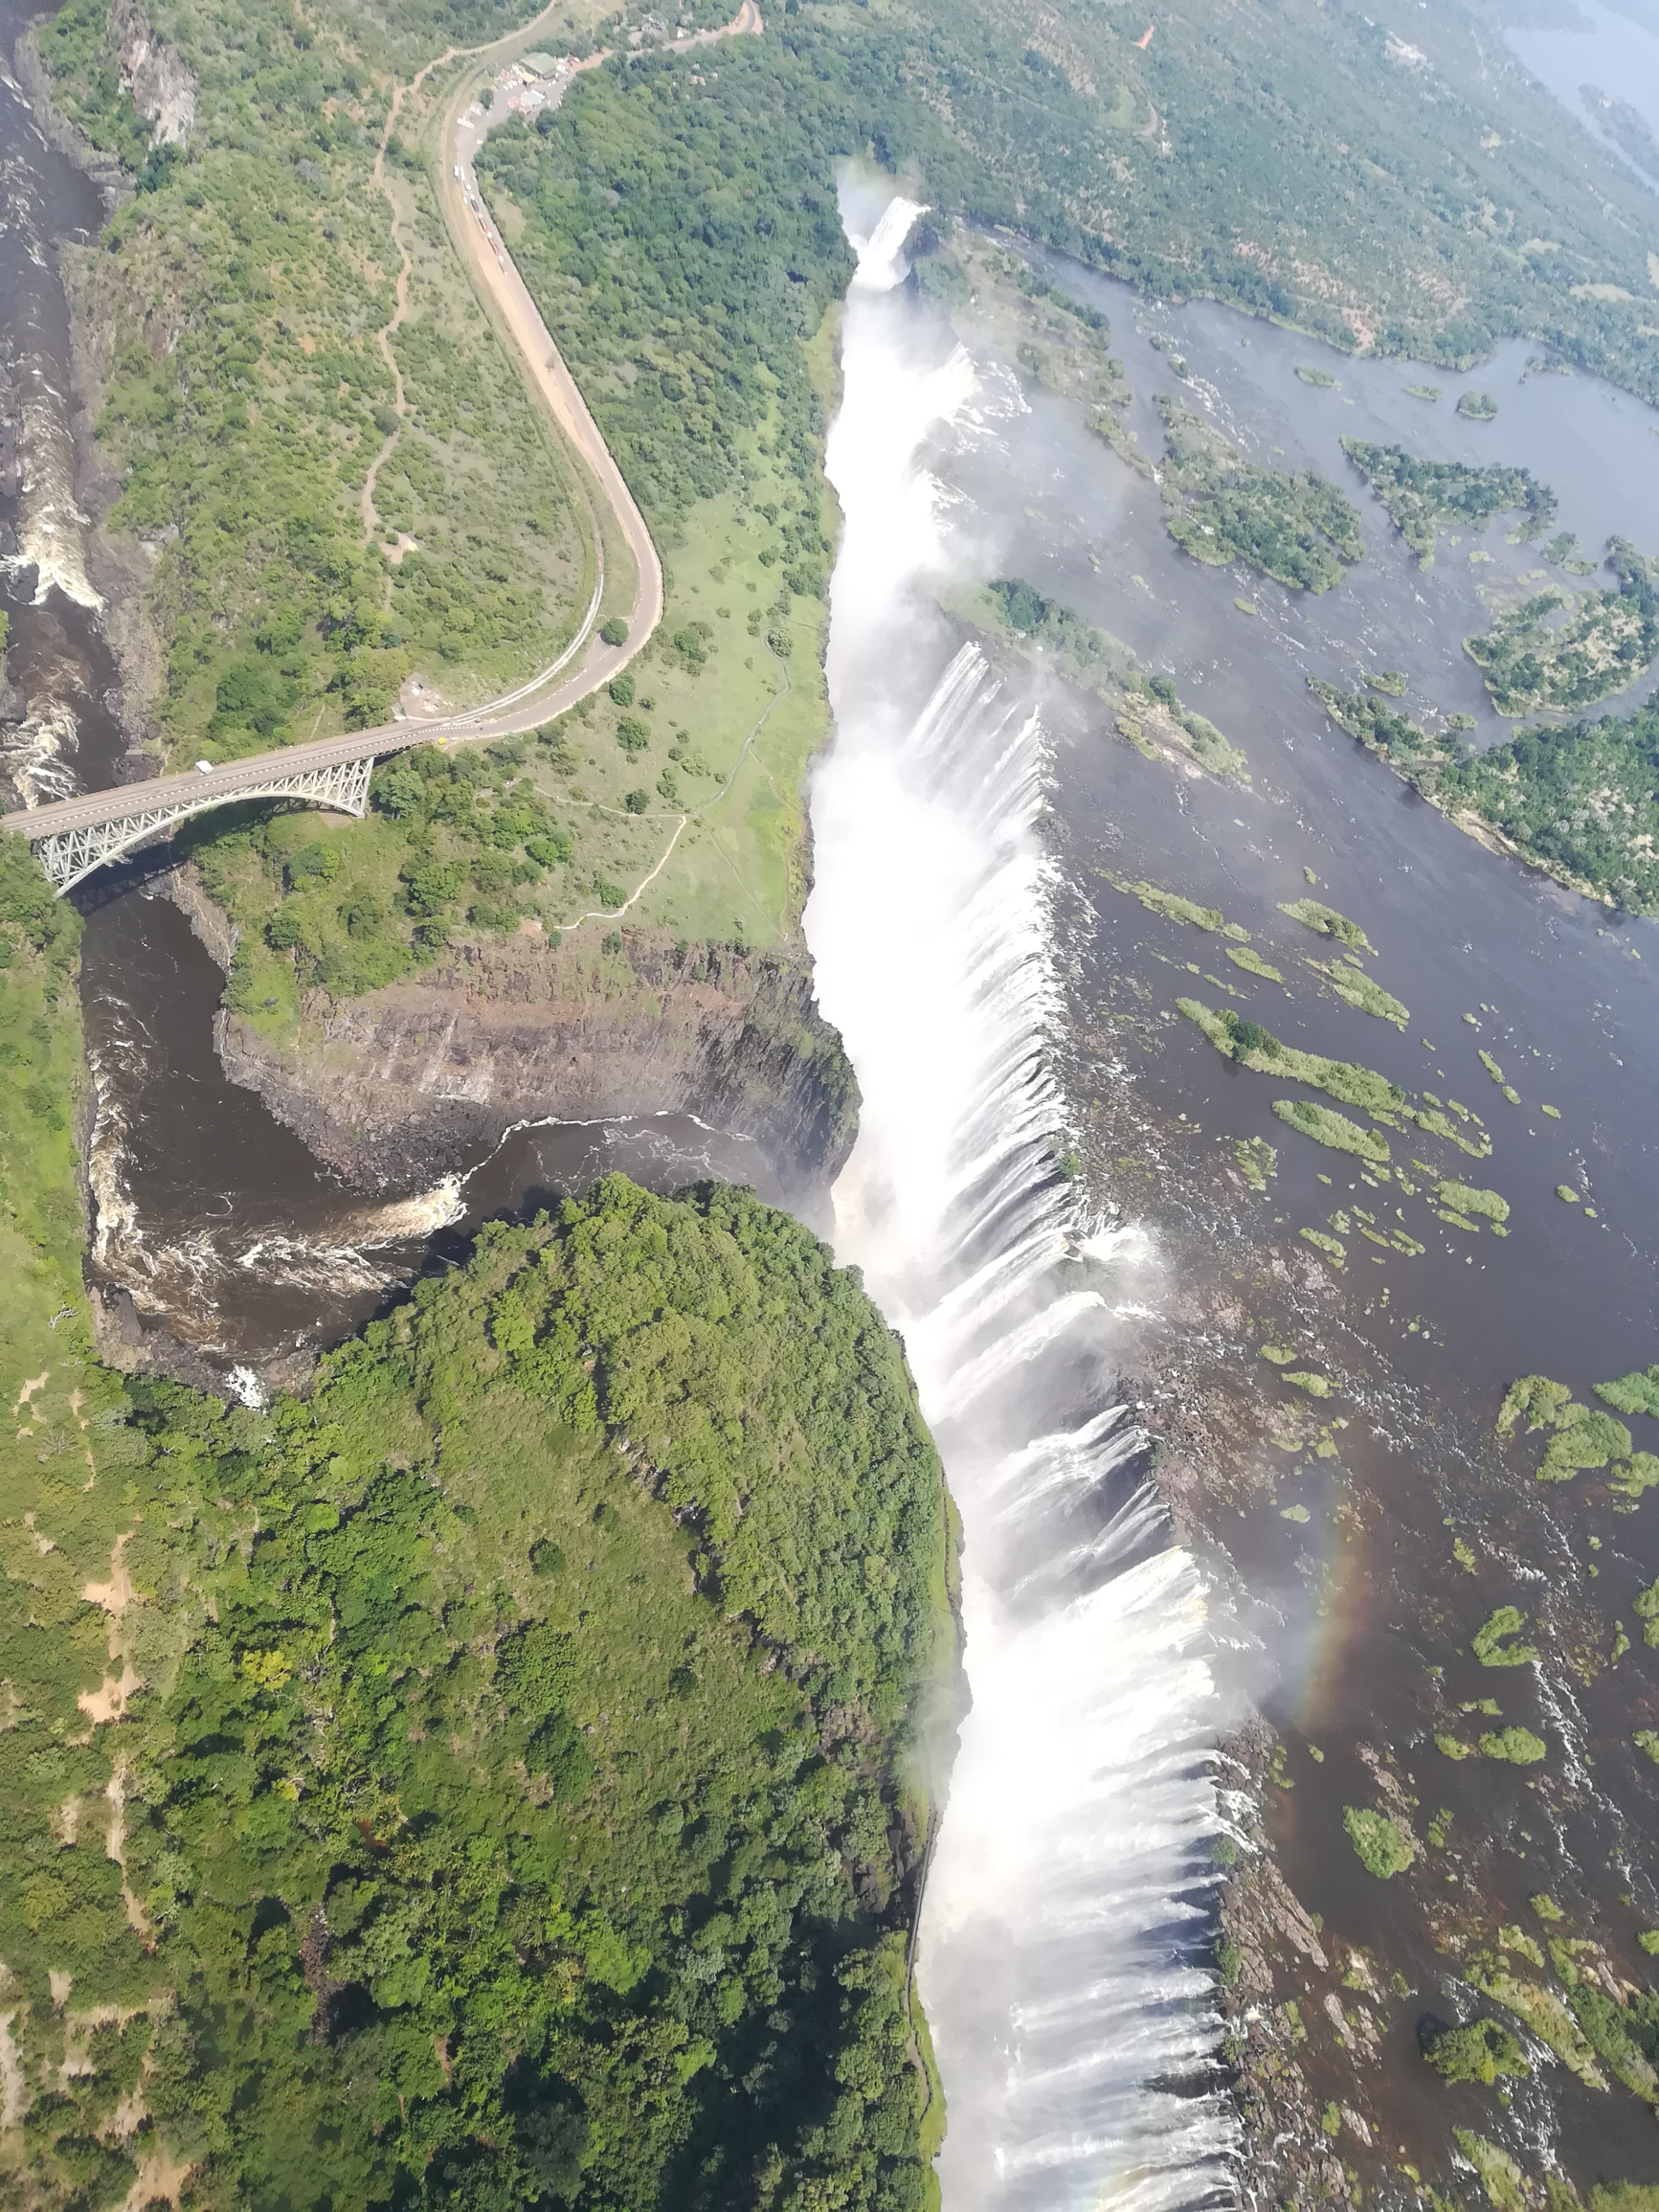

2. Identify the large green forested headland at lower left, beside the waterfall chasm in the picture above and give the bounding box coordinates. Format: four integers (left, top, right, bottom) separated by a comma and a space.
0, 838, 955, 2212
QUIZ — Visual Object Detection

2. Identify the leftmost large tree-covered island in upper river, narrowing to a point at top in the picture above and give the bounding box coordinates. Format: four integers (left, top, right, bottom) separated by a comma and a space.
1156, 394, 1365, 591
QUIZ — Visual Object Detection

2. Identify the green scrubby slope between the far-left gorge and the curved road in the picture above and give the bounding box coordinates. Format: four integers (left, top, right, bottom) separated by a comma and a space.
40, 0, 584, 758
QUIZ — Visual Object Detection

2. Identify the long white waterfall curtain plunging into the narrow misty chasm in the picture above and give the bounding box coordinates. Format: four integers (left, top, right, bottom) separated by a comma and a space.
805, 194, 1237, 2212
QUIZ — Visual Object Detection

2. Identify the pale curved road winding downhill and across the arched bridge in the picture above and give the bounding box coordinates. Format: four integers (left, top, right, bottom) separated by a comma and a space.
0, 0, 761, 841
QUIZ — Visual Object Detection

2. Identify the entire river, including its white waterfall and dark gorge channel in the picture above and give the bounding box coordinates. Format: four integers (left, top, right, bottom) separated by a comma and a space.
0, 0, 1659, 2212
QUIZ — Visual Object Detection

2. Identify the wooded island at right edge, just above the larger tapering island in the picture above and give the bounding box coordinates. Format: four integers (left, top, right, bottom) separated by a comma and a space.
1465, 537, 1659, 714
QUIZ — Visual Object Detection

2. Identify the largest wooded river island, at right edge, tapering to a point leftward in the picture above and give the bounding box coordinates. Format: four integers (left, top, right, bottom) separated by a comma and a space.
1310, 677, 1659, 914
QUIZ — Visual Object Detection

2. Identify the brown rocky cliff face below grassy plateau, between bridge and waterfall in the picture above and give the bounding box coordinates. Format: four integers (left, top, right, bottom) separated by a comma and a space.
216, 934, 859, 1199
